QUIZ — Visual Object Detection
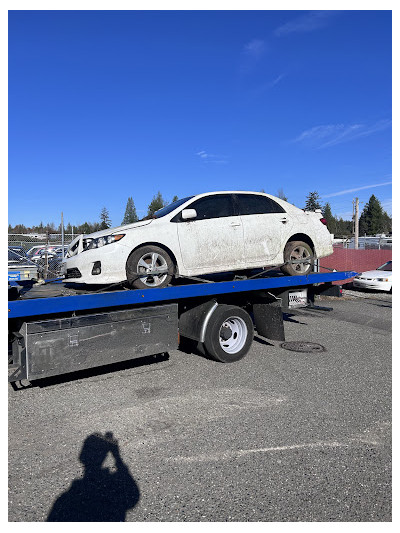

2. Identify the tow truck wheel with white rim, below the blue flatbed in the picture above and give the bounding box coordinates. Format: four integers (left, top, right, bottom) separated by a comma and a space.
204, 305, 254, 363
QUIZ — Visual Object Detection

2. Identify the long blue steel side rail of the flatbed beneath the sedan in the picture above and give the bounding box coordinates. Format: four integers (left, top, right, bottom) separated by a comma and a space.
8, 271, 357, 318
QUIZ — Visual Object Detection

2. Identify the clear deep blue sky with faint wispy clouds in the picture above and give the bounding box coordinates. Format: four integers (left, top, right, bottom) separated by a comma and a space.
8, 11, 392, 226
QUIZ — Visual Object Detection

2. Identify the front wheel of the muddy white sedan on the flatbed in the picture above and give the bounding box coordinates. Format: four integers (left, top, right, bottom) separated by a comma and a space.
126, 246, 175, 289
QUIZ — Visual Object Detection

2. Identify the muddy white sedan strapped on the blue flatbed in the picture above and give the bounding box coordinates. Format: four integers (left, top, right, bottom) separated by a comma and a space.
63, 191, 333, 289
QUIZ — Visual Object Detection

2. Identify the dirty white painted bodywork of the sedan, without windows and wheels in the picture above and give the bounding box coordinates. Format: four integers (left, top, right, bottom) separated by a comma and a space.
64, 191, 333, 284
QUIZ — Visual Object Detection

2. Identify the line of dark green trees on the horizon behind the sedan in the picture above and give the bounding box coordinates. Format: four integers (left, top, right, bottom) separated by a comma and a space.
8, 188, 392, 238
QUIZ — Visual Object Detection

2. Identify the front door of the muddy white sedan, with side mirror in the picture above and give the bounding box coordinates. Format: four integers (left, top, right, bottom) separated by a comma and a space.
177, 194, 244, 273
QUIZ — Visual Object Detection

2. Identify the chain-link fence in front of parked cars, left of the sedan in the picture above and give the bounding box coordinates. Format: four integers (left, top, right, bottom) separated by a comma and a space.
8, 233, 76, 279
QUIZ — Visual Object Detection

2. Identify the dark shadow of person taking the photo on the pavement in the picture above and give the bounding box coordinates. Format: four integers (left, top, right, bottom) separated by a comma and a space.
47, 433, 140, 522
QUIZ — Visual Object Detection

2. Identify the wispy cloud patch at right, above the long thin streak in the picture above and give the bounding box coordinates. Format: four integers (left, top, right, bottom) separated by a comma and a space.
292, 119, 392, 149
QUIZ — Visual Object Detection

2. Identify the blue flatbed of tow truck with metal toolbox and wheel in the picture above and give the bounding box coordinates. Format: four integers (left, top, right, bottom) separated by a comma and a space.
8, 271, 357, 382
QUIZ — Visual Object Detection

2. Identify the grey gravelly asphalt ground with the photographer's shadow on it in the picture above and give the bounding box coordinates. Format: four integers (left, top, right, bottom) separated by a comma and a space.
9, 290, 392, 522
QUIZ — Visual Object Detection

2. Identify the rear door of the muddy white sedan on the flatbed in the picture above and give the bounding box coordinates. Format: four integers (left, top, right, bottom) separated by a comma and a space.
236, 194, 293, 266
